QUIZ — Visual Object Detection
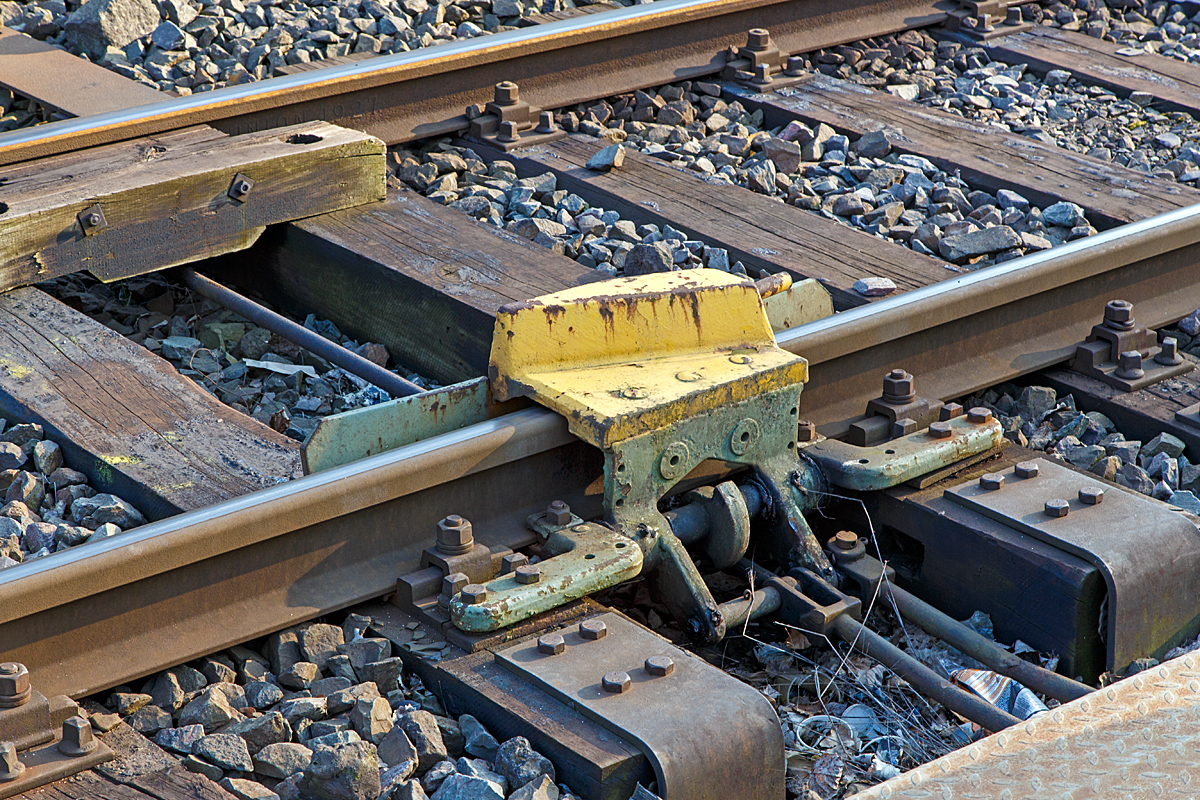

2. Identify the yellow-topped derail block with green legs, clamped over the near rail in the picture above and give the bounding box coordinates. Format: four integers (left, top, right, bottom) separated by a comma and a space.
490, 270, 830, 642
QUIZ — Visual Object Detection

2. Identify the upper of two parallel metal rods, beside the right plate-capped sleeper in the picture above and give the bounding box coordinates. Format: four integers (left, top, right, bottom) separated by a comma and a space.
883, 583, 1093, 703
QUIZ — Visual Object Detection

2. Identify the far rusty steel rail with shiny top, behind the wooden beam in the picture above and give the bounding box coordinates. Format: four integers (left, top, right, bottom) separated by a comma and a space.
0, 0, 956, 166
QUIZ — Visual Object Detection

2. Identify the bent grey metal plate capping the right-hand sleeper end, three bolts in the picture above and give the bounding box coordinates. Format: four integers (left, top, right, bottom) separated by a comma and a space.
946, 458, 1200, 670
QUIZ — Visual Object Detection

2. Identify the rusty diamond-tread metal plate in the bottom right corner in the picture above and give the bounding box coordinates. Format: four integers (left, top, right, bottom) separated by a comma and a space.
851, 655, 1200, 800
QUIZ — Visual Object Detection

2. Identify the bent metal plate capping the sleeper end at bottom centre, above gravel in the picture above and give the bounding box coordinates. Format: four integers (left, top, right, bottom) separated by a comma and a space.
496, 613, 784, 800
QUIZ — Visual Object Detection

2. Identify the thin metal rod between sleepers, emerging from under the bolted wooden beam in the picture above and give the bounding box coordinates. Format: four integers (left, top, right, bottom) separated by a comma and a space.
177, 269, 425, 397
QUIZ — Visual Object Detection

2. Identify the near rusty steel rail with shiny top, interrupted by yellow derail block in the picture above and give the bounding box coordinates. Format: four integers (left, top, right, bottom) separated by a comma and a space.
0, 201, 1200, 697
